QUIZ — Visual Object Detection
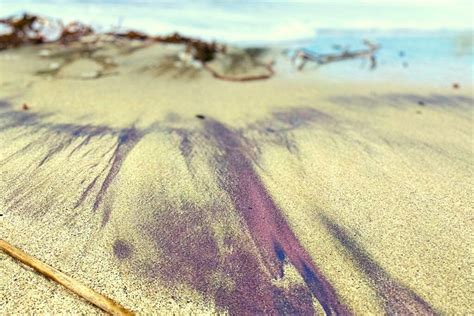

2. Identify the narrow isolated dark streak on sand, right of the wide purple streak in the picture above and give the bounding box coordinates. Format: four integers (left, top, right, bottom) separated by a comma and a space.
321, 216, 437, 315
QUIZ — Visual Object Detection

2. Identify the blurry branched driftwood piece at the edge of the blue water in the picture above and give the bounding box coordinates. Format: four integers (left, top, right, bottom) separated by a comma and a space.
292, 40, 380, 70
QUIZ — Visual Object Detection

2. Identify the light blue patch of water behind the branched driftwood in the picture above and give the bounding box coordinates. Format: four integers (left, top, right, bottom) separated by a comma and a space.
292, 30, 474, 85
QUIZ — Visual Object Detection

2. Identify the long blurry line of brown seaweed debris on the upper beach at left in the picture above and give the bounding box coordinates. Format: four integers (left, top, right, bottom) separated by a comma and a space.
0, 14, 275, 82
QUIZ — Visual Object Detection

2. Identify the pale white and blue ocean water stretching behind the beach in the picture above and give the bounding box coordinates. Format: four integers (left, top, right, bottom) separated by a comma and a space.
0, 0, 474, 86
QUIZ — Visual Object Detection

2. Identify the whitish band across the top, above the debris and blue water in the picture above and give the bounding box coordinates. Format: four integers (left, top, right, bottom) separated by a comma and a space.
0, 0, 474, 42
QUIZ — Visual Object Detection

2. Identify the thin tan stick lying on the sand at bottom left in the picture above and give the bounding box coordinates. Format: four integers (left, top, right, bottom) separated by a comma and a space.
0, 239, 133, 315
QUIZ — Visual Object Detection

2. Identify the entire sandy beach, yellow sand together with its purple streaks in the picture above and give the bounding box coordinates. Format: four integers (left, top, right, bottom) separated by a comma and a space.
0, 41, 474, 314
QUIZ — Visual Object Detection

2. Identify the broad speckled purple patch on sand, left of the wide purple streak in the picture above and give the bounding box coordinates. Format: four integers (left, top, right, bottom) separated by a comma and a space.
146, 202, 298, 315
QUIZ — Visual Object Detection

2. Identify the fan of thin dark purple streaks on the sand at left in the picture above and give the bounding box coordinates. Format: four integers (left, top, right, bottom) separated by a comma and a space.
0, 102, 142, 226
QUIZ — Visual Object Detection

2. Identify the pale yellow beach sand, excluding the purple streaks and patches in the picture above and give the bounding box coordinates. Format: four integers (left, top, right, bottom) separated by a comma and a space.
0, 41, 474, 314
